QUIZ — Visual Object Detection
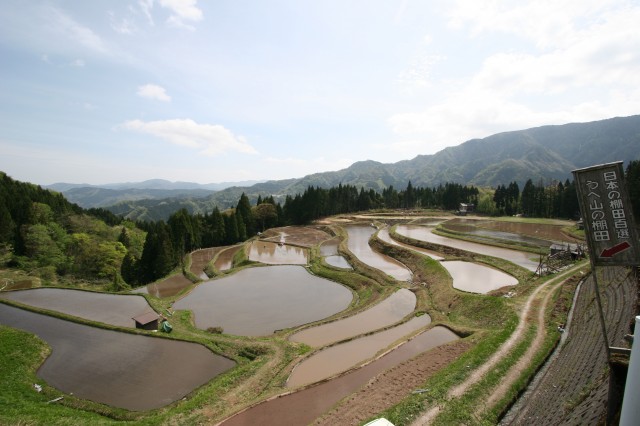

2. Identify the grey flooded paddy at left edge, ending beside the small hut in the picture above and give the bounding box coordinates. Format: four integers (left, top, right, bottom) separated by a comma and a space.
0, 287, 153, 327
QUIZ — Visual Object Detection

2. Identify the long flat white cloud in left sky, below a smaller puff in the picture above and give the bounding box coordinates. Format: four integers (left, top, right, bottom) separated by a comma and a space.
122, 119, 257, 156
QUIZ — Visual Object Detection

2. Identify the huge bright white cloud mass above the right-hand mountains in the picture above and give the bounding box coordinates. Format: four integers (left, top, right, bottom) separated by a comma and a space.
388, 0, 640, 153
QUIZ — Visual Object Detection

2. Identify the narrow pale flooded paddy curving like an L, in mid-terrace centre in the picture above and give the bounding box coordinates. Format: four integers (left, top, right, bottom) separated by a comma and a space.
345, 226, 411, 281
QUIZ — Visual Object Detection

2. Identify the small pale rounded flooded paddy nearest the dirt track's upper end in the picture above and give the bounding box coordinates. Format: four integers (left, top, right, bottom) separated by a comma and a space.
442, 260, 518, 294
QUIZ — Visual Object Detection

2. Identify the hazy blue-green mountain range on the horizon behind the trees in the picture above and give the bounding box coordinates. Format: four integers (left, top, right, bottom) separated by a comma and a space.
49, 115, 640, 220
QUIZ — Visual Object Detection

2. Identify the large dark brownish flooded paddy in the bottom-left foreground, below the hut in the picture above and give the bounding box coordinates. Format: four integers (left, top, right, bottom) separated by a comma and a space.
0, 303, 234, 411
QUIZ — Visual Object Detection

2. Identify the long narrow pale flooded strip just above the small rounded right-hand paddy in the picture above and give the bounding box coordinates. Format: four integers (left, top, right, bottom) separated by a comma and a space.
396, 225, 538, 271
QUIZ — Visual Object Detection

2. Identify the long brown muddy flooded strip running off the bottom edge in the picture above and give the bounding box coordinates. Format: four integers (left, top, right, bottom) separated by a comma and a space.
222, 326, 459, 426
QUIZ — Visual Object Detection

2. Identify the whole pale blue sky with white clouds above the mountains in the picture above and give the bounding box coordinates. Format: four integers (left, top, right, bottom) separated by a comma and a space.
0, 0, 640, 185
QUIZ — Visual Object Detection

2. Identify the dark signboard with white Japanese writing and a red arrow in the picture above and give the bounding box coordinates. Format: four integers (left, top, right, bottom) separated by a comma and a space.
573, 161, 640, 266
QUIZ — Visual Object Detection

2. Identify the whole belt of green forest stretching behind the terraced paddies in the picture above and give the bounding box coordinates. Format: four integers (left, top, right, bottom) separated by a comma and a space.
0, 161, 640, 289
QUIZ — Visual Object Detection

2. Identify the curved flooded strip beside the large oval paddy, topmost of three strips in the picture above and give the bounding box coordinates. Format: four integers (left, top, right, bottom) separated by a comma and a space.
289, 289, 416, 347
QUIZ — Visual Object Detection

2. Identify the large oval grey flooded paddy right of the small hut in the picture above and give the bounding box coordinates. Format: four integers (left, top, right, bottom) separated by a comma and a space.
173, 265, 353, 336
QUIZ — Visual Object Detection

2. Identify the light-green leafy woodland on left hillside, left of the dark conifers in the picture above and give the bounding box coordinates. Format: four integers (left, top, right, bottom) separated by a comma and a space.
0, 173, 139, 282
